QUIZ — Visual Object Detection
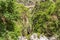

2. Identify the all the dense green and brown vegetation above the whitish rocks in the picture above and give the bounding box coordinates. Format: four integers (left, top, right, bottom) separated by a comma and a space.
0, 0, 60, 40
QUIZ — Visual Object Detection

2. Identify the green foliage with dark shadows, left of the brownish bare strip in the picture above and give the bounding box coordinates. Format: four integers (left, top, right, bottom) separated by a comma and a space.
0, 0, 28, 40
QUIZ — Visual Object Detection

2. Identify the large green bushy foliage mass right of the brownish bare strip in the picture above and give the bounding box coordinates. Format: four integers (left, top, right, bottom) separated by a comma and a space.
32, 1, 60, 36
